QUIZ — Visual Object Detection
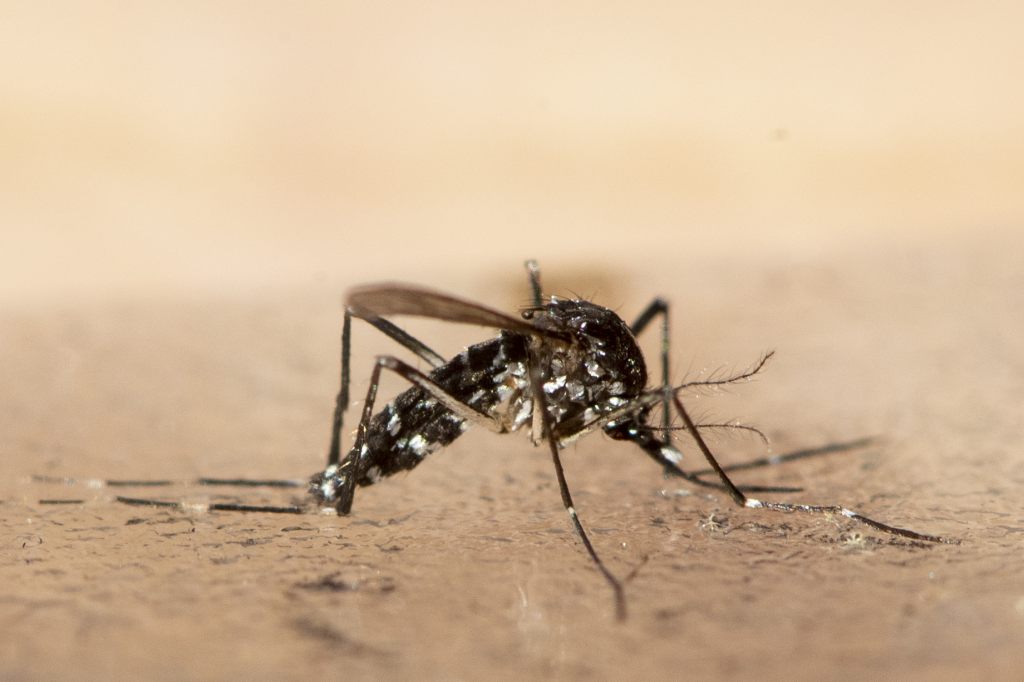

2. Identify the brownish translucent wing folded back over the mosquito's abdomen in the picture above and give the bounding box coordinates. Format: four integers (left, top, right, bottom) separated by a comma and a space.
346, 284, 571, 341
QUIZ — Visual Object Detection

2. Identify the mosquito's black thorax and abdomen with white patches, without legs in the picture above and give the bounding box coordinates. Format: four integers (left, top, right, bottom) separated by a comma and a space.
310, 297, 647, 504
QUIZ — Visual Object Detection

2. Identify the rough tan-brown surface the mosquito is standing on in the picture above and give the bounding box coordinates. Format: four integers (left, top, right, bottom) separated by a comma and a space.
0, 240, 1024, 679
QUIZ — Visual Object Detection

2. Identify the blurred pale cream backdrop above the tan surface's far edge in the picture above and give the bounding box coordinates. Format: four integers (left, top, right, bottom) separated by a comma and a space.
0, 1, 1024, 306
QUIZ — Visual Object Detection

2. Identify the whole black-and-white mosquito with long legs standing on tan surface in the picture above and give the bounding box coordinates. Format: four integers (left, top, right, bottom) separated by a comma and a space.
36, 261, 958, 620
